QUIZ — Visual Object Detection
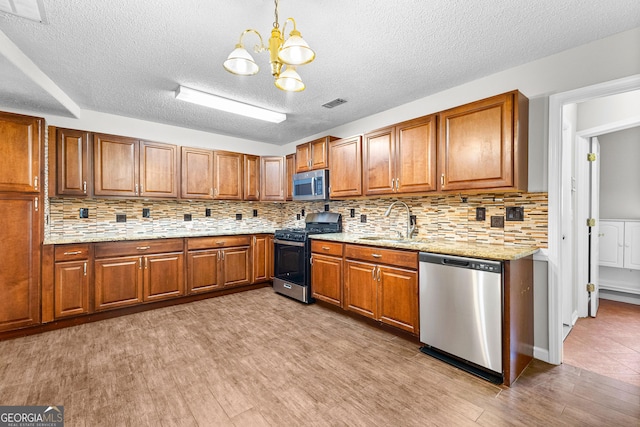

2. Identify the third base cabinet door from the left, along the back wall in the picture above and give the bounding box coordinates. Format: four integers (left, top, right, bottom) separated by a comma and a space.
144, 253, 184, 301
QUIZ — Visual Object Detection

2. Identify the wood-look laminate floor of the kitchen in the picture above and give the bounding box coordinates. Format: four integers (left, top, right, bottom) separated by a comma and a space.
0, 288, 640, 427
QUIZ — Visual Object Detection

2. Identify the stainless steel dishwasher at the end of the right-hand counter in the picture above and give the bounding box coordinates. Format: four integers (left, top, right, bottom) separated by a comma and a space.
420, 252, 503, 384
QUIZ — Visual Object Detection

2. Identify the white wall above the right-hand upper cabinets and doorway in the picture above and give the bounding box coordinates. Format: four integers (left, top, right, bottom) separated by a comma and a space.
283, 27, 640, 192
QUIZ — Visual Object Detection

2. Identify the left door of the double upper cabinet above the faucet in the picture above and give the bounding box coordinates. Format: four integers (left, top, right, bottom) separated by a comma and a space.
362, 127, 395, 195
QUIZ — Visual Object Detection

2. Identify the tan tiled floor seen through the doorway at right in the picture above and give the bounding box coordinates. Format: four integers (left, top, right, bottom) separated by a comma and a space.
563, 299, 640, 386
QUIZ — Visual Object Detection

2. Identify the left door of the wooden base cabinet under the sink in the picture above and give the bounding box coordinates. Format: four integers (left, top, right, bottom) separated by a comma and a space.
343, 260, 378, 319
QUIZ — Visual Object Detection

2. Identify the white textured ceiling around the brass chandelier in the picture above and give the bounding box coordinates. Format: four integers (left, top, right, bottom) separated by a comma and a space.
0, 0, 640, 145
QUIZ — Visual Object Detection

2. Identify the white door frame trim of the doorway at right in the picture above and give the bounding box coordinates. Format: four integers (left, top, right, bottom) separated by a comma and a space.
548, 74, 640, 365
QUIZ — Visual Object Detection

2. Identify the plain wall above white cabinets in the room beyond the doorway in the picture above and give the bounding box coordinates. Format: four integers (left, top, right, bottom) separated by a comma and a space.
598, 127, 640, 219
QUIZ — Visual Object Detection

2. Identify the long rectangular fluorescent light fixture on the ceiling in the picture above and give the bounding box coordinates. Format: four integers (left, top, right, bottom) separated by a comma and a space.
176, 86, 287, 123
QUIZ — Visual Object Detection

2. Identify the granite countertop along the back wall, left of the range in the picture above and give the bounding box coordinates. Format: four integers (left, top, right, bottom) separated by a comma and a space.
44, 229, 275, 245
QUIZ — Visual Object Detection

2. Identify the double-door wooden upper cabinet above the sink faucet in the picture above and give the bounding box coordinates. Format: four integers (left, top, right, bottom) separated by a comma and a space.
363, 115, 437, 195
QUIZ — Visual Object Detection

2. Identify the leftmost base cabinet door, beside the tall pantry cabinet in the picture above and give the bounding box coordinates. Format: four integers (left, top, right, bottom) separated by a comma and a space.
54, 260, 89, 319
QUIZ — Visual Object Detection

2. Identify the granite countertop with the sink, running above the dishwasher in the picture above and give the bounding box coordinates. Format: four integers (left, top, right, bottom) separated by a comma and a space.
310, 233, 539, 261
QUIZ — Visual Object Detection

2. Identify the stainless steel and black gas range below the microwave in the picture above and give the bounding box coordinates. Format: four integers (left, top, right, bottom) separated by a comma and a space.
273, 212, 342, 304
